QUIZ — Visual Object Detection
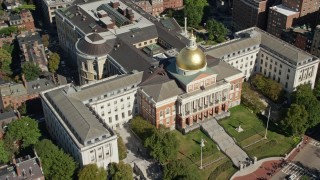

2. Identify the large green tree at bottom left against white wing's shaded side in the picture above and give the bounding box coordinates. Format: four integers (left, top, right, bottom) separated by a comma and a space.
35, 139, 77, 180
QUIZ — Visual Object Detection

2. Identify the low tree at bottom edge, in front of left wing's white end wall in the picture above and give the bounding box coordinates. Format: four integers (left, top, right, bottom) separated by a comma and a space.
78, 164, 107, 180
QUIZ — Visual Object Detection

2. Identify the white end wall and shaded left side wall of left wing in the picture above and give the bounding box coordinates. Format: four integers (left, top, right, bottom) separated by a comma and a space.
42, 93, 119, 168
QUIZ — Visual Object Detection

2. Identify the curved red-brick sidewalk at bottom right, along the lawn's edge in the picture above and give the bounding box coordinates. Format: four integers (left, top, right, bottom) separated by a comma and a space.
231, 136, 310, 180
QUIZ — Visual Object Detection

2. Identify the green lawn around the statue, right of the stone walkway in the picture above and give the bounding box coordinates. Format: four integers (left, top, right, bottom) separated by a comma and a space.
219, 105, 295, 159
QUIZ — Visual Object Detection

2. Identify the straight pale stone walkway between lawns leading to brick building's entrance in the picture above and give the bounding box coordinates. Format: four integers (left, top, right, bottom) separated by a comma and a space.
201, 119, 249, 168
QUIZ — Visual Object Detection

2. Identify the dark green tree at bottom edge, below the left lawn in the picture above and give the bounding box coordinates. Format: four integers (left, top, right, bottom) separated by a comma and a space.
163, 160, 199, 180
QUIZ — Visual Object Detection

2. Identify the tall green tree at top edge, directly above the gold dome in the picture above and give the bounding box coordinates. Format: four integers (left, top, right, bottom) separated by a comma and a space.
184, 0, 208, 27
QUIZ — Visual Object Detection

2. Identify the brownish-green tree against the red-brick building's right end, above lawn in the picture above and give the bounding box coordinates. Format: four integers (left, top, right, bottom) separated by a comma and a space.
241, 82, 266, 113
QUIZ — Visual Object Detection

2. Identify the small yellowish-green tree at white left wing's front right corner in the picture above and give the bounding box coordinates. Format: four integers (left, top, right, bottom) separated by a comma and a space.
108, 161, 133, 180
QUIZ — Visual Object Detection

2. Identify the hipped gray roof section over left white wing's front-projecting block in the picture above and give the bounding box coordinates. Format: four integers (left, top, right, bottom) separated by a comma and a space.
46, 89, 110, 144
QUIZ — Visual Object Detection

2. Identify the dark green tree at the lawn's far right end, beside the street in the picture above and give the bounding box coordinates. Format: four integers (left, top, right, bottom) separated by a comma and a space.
281, 104, 308, 135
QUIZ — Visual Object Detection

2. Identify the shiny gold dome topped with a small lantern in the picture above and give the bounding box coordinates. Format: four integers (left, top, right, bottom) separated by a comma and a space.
176, 33, 207, 70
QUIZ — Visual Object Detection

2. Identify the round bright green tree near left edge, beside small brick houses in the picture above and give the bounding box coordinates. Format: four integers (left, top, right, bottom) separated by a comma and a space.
5, 117, 41, 148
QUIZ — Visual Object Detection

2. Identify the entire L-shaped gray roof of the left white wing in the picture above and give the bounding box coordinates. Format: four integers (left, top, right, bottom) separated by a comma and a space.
45, 72, 142, 144
